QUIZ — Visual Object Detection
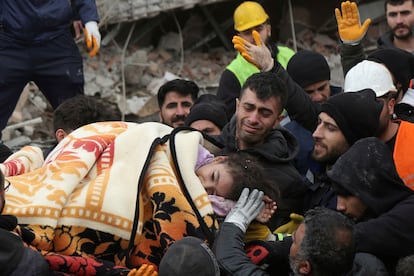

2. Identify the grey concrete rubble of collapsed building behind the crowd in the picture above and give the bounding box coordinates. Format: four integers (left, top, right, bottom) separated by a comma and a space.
2, 0, 386, 149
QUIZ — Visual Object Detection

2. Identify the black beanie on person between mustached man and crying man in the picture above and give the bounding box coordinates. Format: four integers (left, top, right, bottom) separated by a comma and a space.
185, 101, 227, 130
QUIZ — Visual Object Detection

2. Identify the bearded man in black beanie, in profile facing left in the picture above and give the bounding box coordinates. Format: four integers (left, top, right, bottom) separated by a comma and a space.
305, 89, 384, 209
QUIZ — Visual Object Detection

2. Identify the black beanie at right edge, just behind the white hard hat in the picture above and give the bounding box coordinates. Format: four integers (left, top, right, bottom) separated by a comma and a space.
367, 48, 414, 93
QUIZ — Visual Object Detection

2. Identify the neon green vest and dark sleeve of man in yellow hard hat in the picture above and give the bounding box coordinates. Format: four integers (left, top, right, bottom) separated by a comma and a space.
217, 44, 295, 120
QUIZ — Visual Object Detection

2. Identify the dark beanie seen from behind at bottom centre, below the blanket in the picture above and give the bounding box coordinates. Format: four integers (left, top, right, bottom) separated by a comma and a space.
158, 236, 220, 276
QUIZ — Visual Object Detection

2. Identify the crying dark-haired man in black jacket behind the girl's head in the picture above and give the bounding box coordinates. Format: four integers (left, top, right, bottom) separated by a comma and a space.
215, 72, 306, 231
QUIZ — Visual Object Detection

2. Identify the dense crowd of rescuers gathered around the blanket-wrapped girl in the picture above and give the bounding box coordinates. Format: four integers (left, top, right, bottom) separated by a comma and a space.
0, 0, 414, 276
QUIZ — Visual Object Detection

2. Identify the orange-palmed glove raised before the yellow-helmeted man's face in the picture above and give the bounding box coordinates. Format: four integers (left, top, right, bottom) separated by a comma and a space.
232, 30, 274, 71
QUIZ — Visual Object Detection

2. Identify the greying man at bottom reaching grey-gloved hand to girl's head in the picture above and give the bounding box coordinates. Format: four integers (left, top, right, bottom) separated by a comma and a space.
213, 190, 355, 276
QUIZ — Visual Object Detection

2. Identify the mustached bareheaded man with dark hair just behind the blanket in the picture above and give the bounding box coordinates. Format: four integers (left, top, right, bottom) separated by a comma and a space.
157, 79, 200, 128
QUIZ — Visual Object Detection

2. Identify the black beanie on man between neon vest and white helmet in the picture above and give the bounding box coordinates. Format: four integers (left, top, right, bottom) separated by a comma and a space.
286, 50, 331, 88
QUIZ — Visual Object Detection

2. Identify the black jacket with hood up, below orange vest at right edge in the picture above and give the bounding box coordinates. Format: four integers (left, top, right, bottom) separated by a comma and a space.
327, 137, 414, 271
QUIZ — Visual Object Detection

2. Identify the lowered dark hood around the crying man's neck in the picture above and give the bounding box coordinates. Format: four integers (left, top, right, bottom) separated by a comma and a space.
217, 116, 299, 163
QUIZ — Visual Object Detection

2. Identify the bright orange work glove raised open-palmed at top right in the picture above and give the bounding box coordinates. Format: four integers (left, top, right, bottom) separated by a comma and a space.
335, 1, 371, 45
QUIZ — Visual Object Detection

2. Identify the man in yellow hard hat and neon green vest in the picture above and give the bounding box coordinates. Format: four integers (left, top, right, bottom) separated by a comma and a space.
217, 1, 295, 120
